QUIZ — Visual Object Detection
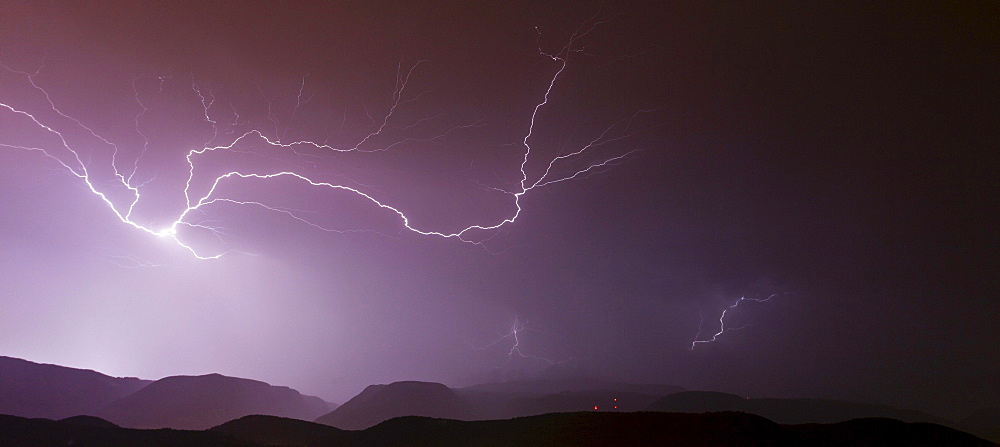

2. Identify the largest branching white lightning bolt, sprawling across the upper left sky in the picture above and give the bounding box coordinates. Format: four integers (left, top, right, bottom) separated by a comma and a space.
0, 16, 656, 260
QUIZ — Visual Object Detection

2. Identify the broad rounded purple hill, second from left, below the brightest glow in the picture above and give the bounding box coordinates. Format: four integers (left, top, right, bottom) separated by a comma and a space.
98, 374, 329, 430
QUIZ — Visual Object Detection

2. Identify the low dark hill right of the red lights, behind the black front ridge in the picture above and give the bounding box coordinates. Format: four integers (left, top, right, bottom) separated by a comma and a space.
648, 391, 953, 425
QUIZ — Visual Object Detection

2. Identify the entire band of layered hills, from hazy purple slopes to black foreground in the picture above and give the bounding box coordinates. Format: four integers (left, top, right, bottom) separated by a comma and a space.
0, 357, 988, 447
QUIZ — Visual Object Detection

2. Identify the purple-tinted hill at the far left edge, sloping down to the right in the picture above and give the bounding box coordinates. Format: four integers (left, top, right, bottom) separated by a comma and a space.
0, 356, 151, 419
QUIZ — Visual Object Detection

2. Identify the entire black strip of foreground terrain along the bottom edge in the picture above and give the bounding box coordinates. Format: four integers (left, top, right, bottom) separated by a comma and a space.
0, 412, 996, 447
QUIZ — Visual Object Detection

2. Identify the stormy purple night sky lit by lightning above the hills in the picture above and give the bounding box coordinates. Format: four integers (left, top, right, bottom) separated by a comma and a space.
0, 0, 1000, 417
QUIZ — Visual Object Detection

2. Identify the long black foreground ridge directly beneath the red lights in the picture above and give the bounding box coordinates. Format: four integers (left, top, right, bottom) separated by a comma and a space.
358, 412, 991, 447
